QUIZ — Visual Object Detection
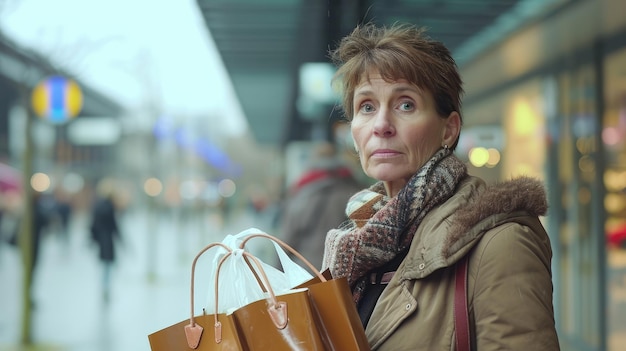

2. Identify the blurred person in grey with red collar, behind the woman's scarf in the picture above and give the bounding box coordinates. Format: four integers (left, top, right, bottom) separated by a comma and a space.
281, 142, 362, 268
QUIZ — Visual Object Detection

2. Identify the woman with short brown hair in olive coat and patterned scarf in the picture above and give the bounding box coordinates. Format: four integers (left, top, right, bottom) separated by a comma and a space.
323, 24, 559, 351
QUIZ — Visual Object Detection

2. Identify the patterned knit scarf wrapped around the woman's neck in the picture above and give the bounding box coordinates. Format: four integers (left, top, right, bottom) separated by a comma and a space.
323, 149, 467, 303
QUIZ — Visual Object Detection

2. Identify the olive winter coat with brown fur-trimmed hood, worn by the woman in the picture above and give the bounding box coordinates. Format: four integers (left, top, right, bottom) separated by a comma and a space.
366, 177, 559, 351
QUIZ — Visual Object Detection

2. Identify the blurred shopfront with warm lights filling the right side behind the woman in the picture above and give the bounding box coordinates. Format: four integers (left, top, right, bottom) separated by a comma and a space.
459, 1, 626, 351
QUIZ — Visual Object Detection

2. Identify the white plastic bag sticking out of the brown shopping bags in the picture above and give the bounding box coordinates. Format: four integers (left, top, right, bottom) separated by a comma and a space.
205, 228, 313, 313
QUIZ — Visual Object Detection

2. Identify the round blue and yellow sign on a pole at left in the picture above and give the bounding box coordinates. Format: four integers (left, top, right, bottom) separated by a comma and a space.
31, 76, 83, 124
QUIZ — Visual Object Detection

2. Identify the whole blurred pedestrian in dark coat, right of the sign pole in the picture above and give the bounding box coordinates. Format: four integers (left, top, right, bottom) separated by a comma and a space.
90, 180, 121, 302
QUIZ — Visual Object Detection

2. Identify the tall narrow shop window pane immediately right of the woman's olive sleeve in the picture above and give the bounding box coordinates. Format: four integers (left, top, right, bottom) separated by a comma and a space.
555, 64, 604, 348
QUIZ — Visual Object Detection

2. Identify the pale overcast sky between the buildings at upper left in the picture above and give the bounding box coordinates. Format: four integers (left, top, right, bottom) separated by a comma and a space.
0, 0, 245, 133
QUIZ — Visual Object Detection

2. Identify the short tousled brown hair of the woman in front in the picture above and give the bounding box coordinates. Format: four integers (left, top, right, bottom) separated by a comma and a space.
330, 23, 463, 140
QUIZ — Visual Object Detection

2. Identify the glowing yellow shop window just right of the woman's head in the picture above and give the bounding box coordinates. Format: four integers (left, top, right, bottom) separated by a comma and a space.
457, 79, 546, 182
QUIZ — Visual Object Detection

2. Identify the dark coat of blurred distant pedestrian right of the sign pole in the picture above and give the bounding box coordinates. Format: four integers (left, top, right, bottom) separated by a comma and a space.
91, 197, 120, 262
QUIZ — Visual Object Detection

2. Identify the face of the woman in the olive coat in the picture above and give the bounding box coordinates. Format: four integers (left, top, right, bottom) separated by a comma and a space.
351, 72, 460, 196
